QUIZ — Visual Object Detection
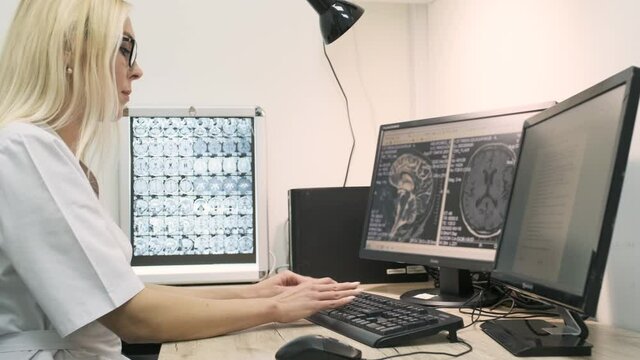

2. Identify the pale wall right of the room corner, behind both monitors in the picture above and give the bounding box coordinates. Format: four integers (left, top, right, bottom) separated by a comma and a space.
418, 0, 640, 330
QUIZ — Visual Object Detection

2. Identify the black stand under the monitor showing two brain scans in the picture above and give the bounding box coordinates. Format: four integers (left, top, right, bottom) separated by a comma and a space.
400, 267, 499, 308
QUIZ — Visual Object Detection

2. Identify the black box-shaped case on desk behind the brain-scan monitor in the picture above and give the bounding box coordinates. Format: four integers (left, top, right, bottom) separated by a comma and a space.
289, 186, 427, 284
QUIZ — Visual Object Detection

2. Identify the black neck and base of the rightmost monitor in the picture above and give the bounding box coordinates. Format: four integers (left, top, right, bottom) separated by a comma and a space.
480, 307, 592, 356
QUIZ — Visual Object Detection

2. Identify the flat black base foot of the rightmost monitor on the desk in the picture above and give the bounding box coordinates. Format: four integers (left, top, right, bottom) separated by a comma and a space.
480, 320, 592, 357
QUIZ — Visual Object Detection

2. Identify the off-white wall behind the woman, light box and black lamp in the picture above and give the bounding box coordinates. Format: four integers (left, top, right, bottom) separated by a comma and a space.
0, 0, 426, 276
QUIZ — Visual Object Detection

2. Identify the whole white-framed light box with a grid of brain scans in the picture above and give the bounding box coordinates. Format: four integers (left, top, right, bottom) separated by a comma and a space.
120, 107, 269, 284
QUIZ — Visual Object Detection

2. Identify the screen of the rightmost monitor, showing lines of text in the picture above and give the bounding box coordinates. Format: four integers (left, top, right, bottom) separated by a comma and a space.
495, 69, 635, 315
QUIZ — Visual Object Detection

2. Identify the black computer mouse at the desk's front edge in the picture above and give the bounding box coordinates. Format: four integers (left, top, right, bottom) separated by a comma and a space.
276, 335, 362, 360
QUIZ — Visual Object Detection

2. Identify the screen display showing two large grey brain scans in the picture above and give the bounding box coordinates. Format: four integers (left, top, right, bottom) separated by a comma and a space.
366, 114, 531, 261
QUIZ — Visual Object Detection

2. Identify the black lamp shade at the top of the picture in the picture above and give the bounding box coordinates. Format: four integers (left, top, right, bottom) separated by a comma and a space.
307, 0, 364, 44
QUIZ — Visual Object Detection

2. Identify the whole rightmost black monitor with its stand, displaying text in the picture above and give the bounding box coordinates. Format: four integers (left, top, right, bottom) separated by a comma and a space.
482, 68, 640, 356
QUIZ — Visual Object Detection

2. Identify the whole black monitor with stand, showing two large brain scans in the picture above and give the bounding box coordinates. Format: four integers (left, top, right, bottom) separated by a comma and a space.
360, 102, 555, 307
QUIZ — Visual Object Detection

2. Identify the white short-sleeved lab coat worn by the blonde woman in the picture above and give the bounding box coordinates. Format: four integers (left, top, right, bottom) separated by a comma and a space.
0, 123, 144, 360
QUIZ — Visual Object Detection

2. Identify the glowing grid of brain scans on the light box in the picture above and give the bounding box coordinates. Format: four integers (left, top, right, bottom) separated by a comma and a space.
131, 117, 255, 264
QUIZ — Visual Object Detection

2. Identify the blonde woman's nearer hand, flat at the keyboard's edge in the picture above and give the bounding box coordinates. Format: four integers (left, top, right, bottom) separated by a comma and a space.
272, 278, 361, 323
